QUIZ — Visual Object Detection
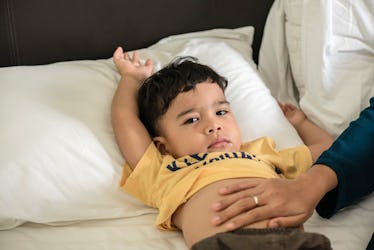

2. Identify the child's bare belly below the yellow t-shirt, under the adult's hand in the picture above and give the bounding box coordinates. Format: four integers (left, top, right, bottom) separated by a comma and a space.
173, 178, 268, 248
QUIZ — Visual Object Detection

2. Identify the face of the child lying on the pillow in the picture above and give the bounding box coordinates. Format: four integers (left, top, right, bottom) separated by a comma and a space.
154, 82, 241, 158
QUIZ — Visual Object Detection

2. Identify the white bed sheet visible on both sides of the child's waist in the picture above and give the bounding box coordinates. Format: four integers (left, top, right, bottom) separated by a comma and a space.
0, 201, 374, 250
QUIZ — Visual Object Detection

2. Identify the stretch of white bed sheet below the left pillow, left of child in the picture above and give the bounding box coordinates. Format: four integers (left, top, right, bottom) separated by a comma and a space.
0, 214, 187, 250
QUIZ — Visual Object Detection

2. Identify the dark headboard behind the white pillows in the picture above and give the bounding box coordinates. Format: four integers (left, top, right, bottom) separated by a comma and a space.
0, 0, 273, 67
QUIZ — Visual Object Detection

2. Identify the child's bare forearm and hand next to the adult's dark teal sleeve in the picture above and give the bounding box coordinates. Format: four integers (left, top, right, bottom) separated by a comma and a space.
278, 102, 334, 161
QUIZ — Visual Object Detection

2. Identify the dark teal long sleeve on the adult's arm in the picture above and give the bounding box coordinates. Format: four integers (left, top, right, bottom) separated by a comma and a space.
315, 98, 374, 218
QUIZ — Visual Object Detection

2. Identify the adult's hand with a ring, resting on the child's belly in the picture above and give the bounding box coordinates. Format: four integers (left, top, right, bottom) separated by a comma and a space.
212, 176, 325, 230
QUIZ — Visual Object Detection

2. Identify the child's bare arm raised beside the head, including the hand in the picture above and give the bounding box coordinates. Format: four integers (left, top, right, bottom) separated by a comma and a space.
111, 47, 153, 168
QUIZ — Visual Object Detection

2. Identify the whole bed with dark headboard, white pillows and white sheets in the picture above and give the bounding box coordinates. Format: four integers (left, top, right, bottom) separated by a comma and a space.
0, 0, 374, 250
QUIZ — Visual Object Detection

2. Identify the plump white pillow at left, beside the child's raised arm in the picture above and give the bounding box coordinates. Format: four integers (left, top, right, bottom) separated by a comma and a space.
0, 60, 155, 229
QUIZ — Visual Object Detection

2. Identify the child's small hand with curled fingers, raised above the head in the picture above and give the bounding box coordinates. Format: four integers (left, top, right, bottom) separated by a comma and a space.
113, 47, 153, 81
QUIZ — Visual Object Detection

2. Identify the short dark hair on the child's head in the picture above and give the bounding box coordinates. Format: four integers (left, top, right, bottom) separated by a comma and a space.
138, 57, 227, 138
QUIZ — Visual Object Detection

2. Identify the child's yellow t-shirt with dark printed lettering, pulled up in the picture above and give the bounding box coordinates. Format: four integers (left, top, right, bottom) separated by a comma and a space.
120, 137, 312, 230
